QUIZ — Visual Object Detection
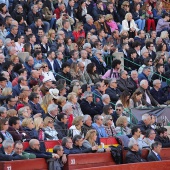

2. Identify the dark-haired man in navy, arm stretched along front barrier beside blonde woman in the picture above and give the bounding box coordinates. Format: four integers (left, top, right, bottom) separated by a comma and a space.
71, 135, 98, 153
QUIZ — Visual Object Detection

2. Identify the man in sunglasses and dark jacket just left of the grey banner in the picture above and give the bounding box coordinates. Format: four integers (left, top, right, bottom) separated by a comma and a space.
112, 104, 126, 126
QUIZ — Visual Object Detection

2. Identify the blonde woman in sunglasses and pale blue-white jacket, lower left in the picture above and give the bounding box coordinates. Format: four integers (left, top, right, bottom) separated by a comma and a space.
44, 117, 58, 140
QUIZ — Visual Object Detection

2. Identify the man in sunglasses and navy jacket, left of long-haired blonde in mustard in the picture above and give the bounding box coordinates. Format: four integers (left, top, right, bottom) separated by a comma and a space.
29, 92, 45, 117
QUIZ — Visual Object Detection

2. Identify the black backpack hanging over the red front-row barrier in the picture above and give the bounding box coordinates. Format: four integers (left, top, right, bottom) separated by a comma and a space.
109, 145, 123, 164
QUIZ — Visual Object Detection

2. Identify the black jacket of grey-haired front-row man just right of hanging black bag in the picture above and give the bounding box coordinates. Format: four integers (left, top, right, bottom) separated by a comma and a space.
125, 150, 146, 163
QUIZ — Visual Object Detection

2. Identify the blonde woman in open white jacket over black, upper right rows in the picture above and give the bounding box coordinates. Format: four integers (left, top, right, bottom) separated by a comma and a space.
122, 13, 139, 38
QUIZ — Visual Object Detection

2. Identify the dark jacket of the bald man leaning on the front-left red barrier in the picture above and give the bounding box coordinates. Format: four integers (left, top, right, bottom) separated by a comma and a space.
25, 147, 52, 159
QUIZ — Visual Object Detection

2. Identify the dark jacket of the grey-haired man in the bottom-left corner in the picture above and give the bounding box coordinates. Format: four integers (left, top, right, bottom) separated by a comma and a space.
0, 147, 22, 161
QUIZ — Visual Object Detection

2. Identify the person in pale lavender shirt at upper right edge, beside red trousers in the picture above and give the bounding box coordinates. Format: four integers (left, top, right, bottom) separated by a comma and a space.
156, 13, 170, 36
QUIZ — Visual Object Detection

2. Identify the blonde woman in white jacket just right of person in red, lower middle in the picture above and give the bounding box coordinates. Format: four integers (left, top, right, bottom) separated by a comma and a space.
69, 116, 84, 138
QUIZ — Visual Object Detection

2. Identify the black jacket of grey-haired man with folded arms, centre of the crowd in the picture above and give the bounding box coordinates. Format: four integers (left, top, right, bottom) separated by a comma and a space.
80, 99, 100, 118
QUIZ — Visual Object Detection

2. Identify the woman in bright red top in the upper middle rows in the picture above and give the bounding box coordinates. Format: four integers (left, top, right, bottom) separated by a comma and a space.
73, 22, 85, 42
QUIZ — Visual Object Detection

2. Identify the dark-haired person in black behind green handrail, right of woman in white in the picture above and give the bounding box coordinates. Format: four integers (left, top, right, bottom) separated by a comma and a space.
56, 62, 72, 85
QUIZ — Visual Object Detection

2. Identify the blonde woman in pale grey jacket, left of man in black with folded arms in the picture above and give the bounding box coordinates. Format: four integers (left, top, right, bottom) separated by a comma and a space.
67, 92, 83, 118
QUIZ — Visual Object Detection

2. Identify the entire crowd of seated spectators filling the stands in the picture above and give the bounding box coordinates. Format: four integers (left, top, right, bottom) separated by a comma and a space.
0, 0, 170, 169
